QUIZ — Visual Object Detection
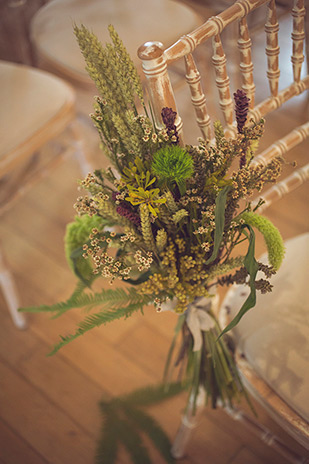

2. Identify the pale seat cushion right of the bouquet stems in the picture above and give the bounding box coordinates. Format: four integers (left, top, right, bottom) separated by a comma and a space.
223, 234, 309, 421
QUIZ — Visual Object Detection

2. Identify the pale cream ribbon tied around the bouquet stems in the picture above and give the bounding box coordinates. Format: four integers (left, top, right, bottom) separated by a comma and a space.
161, 295, 219, 351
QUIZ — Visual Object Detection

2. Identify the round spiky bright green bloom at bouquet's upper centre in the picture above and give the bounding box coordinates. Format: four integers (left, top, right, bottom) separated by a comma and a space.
152, 145, 193, 195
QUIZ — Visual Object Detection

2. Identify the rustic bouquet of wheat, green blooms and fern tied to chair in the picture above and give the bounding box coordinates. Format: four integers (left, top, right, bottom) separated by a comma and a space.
23, 26, 284, 414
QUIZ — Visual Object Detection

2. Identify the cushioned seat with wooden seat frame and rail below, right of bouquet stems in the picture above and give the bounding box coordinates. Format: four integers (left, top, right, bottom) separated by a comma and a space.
221, 220, 309, 463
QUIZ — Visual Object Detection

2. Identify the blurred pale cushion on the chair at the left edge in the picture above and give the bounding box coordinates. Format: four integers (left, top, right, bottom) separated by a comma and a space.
0, 61, 75, 173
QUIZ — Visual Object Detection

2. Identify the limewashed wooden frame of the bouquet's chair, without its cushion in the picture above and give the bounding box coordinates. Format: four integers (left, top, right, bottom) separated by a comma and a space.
138, 0, 309, 463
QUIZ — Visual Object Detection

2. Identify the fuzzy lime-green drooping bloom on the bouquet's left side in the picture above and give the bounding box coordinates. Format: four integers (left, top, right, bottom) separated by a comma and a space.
64, 214, 103, 281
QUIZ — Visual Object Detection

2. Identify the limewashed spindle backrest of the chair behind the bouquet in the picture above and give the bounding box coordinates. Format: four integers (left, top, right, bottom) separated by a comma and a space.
138, 0, 309, 201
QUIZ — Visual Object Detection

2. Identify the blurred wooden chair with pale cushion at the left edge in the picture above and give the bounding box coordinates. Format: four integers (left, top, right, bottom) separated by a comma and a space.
0, 61, 92, 328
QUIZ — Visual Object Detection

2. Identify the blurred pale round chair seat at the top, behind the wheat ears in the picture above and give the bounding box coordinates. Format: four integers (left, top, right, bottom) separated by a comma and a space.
31, 0, 201, 80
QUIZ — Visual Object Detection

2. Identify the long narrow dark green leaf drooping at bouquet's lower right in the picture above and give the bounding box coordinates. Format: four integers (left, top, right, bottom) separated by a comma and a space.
219, 225, 259, 338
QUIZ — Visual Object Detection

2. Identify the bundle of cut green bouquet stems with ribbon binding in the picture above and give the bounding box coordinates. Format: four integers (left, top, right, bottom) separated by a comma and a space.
164, 298, 251, 415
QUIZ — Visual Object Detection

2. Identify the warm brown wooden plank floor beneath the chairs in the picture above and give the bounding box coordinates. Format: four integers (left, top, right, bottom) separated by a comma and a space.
0, 1, 309, 464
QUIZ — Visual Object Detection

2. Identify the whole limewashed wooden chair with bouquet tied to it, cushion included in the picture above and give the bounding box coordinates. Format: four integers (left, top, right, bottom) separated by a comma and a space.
139, 0, 309, 463
